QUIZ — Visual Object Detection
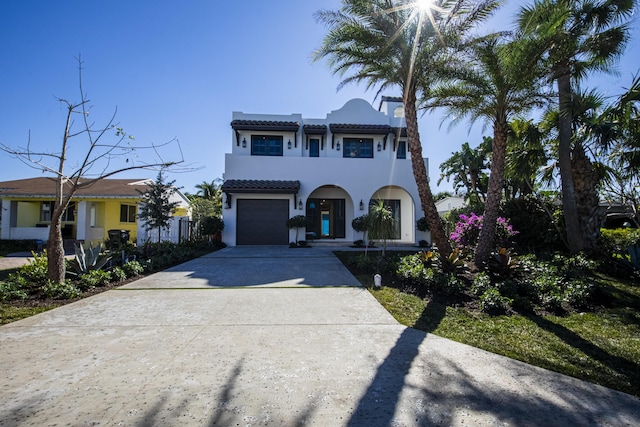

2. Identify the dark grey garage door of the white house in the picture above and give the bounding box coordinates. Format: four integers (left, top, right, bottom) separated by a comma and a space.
236, 199, 289, 245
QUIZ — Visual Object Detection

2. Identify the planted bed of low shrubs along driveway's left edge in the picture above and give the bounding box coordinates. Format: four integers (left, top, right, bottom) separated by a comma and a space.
0, 241, 224, 324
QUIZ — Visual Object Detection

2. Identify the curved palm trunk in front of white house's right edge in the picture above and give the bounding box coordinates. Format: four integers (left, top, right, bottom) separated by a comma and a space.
404, 90, 451, 258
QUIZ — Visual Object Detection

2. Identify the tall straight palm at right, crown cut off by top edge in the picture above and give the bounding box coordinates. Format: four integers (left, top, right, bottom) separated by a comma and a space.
518, 0, 636, 253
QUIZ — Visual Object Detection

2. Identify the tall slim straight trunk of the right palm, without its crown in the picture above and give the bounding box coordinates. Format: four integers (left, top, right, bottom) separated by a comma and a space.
558, 72, 584, 254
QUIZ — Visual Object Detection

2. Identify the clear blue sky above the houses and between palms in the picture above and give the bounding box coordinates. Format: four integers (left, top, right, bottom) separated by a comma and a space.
0, 0, 640, 193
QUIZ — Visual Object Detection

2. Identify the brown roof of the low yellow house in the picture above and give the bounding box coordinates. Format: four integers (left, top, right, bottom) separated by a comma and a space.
0, 177, 150, 198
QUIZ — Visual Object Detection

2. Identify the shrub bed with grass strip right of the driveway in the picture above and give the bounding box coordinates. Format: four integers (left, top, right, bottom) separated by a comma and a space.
336, 249, 640, 396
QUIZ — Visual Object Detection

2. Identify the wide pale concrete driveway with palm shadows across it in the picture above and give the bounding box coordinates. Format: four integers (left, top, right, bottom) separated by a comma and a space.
0, 248, 640, 426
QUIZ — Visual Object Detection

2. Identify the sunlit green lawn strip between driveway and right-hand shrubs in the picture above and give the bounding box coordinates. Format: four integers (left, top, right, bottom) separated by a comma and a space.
357, 274, 640, 396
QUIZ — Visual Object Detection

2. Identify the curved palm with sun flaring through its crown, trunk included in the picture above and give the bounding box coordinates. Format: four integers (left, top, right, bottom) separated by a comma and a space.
314, 0, 498, 257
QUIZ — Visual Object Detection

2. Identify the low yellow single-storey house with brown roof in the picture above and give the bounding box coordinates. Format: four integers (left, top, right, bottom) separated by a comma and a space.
0, 178, 189, 244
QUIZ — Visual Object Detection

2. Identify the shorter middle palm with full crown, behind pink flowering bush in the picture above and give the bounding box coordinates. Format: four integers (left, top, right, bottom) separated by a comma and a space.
427, 34, 544, 266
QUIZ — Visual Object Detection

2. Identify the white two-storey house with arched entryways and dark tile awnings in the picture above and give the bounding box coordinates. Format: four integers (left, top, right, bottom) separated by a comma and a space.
222, 97, 430, 246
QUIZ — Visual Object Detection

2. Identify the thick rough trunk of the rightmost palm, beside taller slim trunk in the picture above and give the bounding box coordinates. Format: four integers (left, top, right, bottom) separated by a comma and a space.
571, 144, 602, 251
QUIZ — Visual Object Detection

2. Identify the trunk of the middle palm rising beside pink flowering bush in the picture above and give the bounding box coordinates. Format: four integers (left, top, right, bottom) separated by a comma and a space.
474, 119, 507, 267
